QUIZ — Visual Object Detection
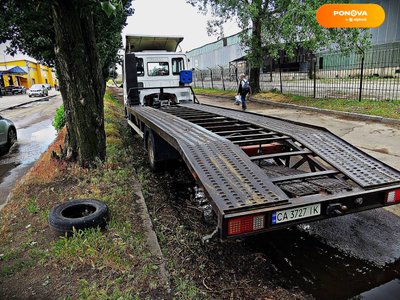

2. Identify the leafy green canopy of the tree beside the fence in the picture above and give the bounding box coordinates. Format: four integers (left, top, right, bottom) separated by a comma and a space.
186, 0, 370, 67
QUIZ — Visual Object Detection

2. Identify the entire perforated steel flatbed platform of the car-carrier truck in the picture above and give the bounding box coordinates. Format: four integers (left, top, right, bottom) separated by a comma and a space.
127, 104, 400, 237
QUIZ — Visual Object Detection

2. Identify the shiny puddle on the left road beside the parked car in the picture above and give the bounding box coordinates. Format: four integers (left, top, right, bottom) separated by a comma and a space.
0, 119, 56, 209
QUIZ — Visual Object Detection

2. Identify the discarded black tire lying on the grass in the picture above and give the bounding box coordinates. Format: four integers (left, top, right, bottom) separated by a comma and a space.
49, 199, 108, 234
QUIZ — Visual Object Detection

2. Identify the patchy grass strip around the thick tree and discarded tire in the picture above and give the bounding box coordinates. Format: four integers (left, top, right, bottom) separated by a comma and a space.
0, 93, 164, 299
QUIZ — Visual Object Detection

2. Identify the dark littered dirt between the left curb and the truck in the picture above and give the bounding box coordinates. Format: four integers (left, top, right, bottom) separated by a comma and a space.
128, 139, 304, 299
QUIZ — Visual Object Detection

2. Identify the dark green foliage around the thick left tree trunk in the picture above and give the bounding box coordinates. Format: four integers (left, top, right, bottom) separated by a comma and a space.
0, 0, 134, 78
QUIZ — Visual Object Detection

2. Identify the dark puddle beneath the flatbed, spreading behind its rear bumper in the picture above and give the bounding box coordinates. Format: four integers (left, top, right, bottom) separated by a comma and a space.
161, 163, 400, 300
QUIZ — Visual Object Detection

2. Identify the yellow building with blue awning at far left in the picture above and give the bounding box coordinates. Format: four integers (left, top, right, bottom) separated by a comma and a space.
0, 59, 58, 89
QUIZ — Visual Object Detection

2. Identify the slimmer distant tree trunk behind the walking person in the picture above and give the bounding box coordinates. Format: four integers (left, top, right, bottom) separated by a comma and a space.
250, 18, 263, 93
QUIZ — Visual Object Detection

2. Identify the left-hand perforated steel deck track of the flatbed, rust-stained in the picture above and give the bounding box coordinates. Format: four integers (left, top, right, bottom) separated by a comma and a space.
131, 106, 289, 213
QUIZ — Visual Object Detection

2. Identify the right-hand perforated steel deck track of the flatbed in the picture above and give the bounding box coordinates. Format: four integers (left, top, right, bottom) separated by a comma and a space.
181, 104, 400, 188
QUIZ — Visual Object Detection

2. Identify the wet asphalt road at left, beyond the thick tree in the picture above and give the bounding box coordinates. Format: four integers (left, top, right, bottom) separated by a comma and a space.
0, 95, 61, 209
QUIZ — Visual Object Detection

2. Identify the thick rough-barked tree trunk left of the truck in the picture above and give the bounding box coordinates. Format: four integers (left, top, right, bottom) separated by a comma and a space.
52, 0, 106, 167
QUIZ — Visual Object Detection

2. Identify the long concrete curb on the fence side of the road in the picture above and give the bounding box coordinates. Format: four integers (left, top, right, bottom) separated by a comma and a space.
198, 94, 400, 125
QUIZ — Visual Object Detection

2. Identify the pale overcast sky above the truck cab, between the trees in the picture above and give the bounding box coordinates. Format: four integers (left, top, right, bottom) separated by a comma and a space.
122, 0, 240, 52
